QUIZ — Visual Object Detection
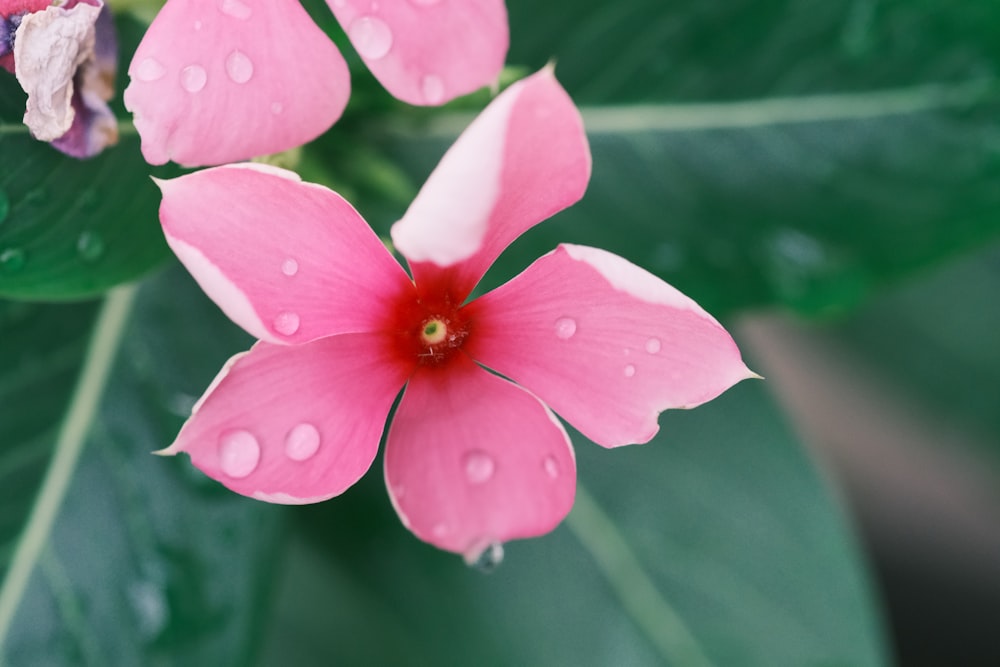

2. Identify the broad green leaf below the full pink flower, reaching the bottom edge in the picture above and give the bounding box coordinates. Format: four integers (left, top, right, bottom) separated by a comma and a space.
262, 383, 885, 667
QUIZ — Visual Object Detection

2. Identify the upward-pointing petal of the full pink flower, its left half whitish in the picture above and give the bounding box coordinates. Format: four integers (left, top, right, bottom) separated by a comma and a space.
392, 68, 590, 303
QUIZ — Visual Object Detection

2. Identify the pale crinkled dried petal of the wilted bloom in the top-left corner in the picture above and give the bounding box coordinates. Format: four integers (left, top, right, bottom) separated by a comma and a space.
14, 3, 101, 141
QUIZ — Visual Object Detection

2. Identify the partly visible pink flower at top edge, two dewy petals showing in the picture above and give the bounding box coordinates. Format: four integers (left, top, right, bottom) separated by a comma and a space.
125, 0, 508, 166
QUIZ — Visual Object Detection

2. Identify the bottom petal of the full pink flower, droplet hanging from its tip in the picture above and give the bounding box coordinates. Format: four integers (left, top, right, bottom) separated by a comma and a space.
385, 354, 576, 559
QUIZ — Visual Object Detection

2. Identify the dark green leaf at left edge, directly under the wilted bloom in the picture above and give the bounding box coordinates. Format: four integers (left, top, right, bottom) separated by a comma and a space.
0, 21, 177, 300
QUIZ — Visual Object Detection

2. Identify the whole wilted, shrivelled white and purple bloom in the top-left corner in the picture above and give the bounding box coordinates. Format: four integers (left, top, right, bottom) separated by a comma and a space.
0, 0, 118, 158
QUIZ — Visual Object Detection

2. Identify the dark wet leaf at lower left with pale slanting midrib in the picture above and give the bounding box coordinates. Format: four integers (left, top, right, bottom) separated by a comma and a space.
0, 270, 282, 667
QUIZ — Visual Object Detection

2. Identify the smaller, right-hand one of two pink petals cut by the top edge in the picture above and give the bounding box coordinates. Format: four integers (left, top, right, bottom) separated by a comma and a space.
327, 0, 509, 106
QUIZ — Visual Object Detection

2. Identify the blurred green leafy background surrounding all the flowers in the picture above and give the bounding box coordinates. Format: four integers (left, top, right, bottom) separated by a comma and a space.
0, 0, 1000, 667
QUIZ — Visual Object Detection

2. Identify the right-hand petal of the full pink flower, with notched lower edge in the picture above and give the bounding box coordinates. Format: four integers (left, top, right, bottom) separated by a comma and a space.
465, 245, 754, 447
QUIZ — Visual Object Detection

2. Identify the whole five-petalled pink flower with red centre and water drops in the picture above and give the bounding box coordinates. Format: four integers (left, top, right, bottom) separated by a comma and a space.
154, 69, 752, 557
